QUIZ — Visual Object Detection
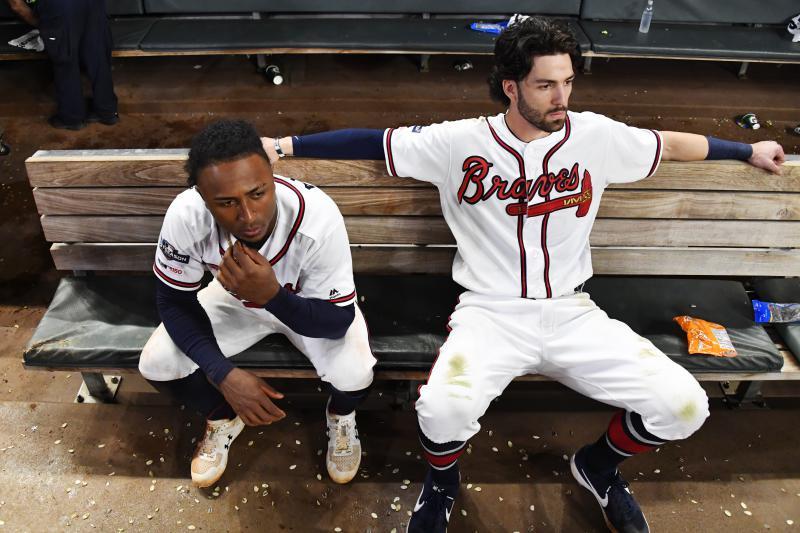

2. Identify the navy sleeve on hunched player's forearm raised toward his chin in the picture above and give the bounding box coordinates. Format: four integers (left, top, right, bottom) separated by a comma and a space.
264, 287, 356, 339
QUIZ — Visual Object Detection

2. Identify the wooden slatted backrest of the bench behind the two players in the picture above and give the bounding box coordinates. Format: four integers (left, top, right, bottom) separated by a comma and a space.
26, 150, 800, 276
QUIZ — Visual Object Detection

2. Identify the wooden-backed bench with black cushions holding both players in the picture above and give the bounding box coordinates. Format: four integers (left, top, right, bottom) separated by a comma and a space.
24, 150, 800, 403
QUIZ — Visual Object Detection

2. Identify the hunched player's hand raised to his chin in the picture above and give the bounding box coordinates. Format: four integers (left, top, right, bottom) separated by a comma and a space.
217, 241, 281, 307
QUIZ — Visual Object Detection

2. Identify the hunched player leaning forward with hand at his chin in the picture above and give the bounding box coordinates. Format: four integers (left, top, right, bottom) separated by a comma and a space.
139, 121, 375, 487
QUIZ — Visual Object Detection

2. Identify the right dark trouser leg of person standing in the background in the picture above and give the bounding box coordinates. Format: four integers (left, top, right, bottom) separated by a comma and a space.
80, 0, 117, 118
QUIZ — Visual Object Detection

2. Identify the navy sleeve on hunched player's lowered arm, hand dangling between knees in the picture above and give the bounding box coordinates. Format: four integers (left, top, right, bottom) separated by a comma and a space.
156, 283, 234, 385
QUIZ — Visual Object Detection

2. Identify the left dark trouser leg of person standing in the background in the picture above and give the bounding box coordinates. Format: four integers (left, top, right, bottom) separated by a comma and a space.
38, 0, 86, 124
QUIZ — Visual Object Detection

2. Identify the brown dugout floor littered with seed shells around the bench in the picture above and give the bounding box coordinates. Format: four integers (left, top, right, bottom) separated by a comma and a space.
0, 56, 800, 532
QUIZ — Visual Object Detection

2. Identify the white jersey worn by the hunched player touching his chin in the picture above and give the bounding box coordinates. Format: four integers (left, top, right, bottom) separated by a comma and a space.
153, 176, 356, 307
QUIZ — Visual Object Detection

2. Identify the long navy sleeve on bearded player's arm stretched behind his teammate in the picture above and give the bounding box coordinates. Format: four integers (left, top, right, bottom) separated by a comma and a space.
292, 128, 384, 160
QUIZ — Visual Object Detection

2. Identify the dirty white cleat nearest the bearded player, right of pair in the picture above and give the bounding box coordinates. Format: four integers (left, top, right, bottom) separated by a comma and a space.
325, 399, 361, 483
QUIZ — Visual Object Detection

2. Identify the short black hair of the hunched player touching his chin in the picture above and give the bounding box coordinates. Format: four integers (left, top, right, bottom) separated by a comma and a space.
185, 119, 269, 187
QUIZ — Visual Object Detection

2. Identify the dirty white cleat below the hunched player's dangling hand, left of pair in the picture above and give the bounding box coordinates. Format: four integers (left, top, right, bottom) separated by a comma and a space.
192, 416, 244, 488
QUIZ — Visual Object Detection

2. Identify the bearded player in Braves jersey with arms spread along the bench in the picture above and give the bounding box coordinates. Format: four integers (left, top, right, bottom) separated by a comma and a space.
264, 17, 783, 532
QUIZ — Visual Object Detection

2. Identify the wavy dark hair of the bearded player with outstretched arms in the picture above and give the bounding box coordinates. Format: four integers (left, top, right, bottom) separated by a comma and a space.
488, 17, 579, 105
